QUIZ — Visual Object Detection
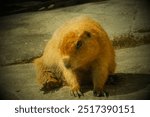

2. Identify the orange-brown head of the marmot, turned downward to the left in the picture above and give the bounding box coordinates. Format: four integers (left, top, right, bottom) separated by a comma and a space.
60, 29, 100, 70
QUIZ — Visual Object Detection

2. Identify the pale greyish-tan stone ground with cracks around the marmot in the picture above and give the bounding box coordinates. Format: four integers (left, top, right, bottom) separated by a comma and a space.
0, 0, 150, 99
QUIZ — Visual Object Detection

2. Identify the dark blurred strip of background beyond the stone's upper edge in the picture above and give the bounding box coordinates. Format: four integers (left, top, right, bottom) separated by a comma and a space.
0, 0, 100, 15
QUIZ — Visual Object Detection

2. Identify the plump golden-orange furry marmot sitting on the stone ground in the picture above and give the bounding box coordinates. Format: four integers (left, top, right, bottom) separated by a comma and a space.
34, 16, 116, 96
